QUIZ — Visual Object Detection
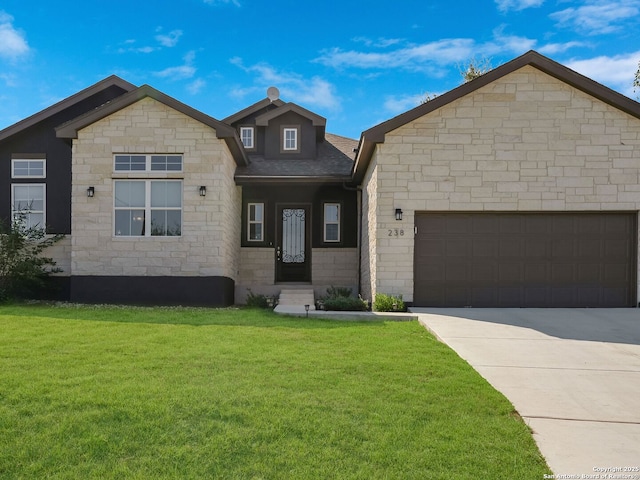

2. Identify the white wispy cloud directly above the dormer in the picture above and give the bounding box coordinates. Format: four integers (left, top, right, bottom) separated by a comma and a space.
230, 57, 340, 111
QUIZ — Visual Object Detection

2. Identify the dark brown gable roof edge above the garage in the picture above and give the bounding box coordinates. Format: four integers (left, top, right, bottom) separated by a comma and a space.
353, 50, 640, 183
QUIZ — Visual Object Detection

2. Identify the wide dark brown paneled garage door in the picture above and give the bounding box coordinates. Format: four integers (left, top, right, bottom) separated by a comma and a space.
414, 212, 637, 307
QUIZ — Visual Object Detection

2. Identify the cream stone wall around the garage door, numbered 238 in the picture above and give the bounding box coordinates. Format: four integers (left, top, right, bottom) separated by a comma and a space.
363, 66, 640, 301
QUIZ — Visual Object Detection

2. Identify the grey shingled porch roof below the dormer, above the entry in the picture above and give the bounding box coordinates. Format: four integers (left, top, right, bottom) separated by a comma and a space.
235, 133, 358, 184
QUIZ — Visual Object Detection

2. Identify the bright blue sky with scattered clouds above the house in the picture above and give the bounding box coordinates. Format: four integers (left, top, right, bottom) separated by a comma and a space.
0, 0, 640, 138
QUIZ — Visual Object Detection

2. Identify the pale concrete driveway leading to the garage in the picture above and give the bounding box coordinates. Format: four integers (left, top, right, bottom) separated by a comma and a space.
411, 308, 640, 479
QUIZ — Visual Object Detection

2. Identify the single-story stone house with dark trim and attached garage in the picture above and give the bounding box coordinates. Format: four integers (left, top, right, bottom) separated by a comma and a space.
0, 51, 640, 307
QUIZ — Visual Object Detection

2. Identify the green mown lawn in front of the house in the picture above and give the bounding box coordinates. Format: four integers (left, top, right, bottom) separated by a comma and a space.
0, 305, 549, 480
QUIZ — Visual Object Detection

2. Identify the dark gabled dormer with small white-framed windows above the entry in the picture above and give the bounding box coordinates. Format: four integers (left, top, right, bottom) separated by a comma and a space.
223, 92, 327, 160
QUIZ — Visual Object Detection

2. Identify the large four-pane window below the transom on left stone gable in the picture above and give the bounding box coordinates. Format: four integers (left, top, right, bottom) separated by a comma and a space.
114, 180, 182, 237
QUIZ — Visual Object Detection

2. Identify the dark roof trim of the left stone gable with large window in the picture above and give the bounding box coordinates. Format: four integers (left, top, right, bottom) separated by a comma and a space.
56, 85, 247, 165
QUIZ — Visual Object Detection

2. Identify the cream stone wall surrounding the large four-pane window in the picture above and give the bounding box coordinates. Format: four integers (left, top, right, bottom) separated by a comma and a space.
71, 98, 241, 279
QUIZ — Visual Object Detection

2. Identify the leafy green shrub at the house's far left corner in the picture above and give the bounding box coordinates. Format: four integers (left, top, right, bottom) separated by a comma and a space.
0, 213, 64, 301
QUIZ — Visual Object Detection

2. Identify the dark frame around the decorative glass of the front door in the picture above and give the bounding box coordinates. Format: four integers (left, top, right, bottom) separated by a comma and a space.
274, 202, 312, 283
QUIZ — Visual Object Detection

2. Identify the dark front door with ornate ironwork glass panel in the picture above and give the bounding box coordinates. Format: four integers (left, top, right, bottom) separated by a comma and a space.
276, 205, 311, 282
